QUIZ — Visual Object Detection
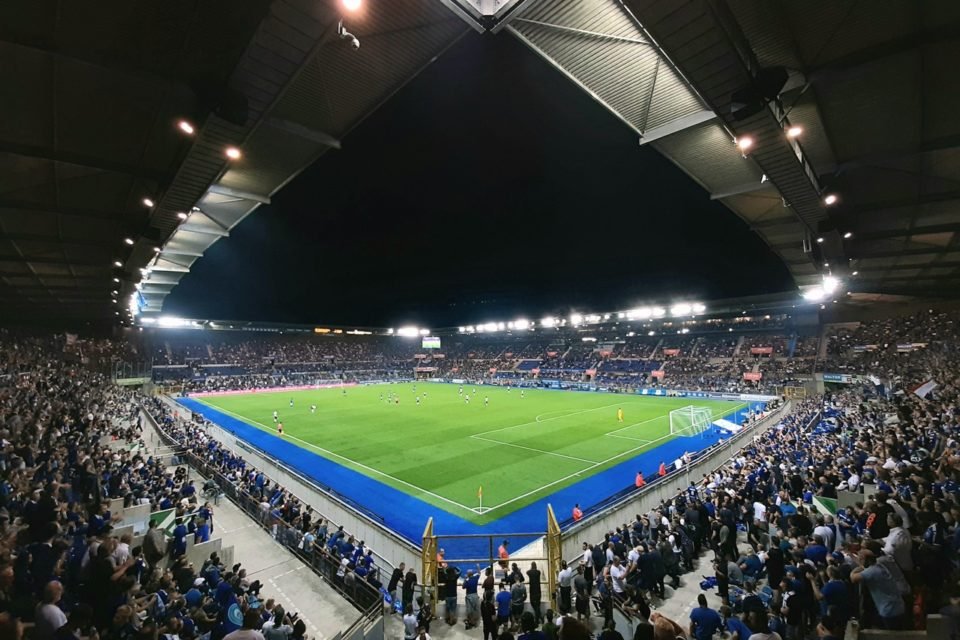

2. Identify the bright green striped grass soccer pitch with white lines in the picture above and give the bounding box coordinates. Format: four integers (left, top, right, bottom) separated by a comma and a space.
200, 383, 745, 524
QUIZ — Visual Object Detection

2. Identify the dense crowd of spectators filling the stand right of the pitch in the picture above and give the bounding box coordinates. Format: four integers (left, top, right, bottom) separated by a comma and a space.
560, 317, 960, 640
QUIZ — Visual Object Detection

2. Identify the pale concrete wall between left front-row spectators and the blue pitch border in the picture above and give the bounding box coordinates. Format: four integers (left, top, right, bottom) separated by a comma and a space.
160, 395, 421, 571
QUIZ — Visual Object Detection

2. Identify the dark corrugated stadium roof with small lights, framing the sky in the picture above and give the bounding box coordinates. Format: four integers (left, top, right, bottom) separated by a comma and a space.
0, 0, 960, 318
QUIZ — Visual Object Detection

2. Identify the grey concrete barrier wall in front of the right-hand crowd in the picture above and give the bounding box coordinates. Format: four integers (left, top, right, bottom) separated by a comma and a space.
561, 402, 791, 561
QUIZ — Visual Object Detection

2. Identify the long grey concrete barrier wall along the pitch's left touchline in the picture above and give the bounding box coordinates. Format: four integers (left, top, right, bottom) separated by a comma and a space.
151, 398, 420, 576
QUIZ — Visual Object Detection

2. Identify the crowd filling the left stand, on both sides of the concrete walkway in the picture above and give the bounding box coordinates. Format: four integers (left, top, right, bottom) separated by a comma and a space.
0, 331, 376, 640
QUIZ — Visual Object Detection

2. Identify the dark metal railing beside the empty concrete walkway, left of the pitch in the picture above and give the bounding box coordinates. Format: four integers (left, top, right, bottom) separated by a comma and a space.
140, 406, 384, 639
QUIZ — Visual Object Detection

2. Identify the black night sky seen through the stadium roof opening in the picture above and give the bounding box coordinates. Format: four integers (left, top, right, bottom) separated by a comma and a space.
164, 33, 792, 326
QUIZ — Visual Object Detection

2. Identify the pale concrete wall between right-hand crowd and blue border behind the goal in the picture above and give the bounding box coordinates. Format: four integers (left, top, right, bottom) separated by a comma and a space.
560, 401, 808, 561
